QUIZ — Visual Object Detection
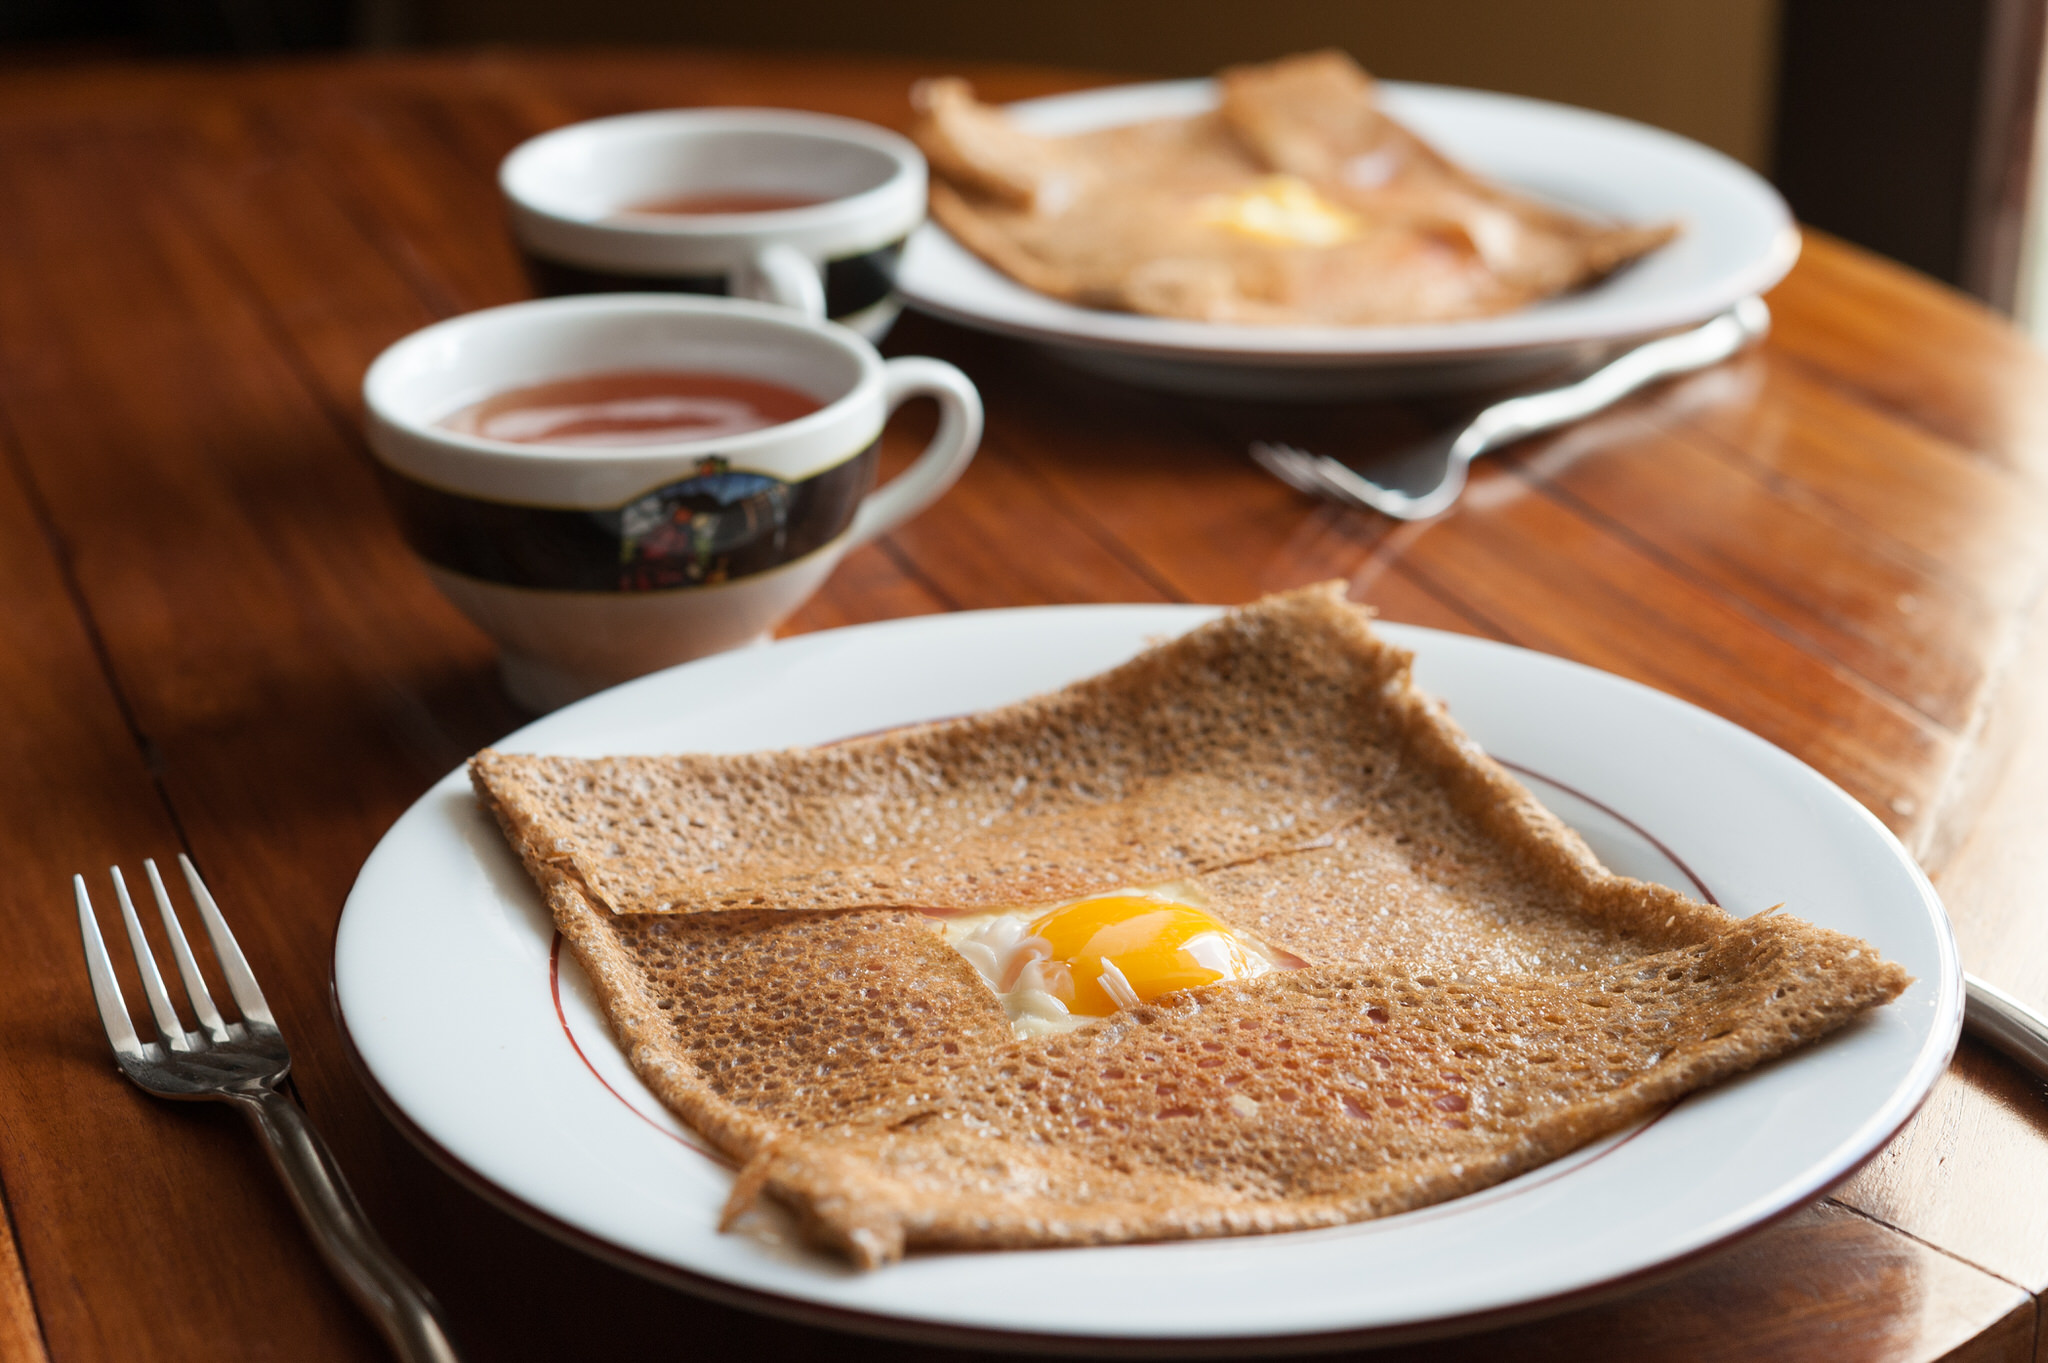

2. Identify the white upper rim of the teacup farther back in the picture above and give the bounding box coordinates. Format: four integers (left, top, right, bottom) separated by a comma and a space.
498, 108, 926, 272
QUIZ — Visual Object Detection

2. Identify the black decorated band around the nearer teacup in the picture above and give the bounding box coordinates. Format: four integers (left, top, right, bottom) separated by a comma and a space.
377, 440, 881, 591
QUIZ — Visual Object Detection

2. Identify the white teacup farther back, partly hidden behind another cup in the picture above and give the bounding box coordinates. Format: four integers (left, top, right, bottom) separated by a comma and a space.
498, 108, 926, 340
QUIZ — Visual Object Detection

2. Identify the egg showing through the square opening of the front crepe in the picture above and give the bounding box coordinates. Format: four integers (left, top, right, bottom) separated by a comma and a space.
946, 884, 1280, 1038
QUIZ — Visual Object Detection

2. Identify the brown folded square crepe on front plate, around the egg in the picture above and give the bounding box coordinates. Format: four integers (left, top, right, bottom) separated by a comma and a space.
471, 585, 1909, 1267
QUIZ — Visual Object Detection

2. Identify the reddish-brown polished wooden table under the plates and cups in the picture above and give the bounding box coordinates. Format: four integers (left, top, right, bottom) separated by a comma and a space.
0, 53, 2048, 1363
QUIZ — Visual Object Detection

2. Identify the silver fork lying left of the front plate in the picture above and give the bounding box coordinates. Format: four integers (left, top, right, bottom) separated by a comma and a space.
72, 855, 459, 1363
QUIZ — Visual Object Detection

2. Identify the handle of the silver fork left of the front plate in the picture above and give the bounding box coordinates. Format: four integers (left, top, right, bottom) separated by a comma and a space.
236, 1089, 461, 1363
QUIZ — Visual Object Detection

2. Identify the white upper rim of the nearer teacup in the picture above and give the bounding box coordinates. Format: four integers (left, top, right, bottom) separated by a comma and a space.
362, 293, 887, 510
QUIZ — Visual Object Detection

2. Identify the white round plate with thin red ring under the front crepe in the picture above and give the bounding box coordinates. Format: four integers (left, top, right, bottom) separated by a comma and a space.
334, 606, 1962, 1353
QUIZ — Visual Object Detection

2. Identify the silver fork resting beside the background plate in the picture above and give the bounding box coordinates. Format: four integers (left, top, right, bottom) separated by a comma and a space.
1251, 299, 1772, 520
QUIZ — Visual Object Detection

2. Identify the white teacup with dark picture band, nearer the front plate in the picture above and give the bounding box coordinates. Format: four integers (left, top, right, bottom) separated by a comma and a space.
362, 295, 981, 710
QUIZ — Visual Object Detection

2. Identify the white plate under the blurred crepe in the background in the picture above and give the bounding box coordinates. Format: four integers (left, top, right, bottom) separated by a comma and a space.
899, 80, 1798, 397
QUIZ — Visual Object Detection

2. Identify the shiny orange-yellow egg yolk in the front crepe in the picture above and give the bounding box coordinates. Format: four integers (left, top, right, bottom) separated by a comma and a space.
1030, 894, 1253, 1017
